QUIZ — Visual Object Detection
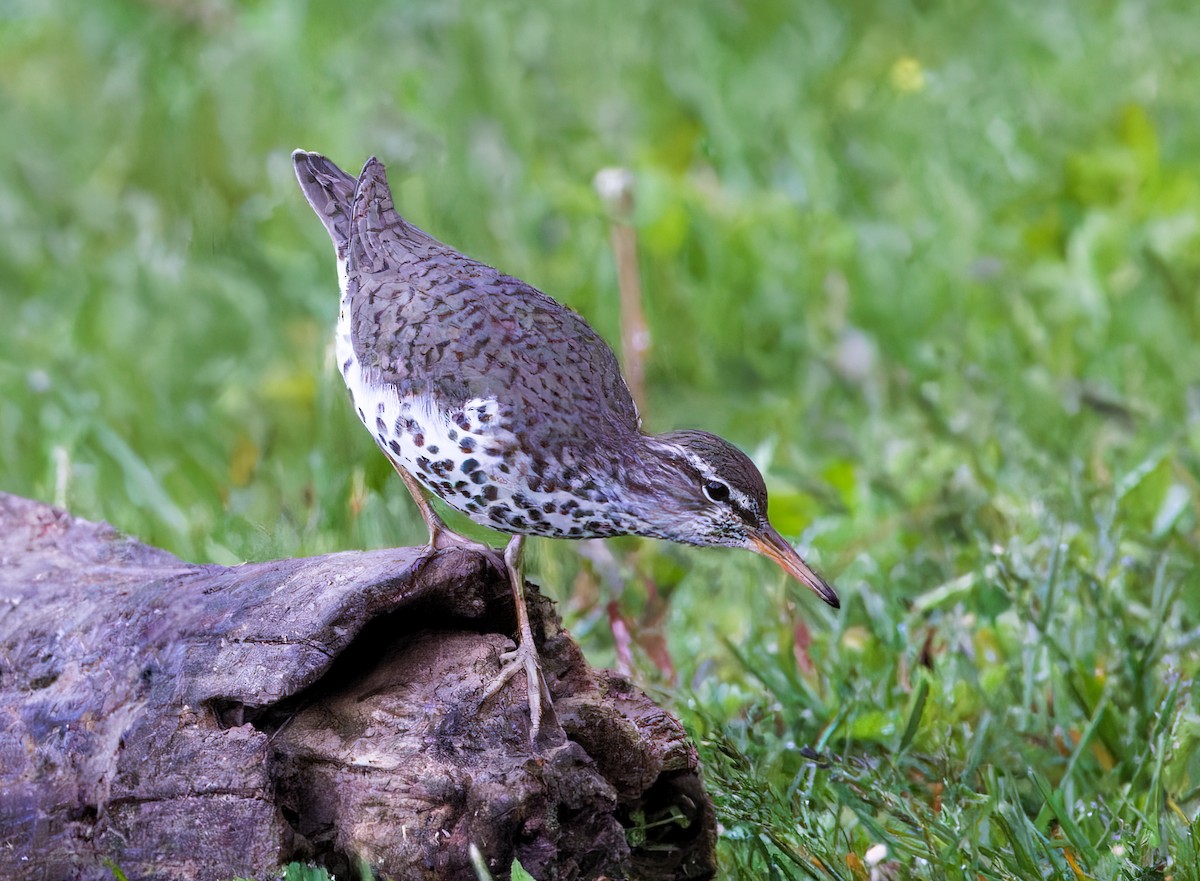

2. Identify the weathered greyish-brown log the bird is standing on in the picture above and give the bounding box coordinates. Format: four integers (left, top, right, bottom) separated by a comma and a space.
0, 495, 715, 881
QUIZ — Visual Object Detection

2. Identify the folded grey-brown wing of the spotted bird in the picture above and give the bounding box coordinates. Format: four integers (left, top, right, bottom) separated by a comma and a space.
347, 158, 638, 442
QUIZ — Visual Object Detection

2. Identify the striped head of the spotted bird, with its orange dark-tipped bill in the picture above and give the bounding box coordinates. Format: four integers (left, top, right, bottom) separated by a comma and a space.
647, 431, 840, 609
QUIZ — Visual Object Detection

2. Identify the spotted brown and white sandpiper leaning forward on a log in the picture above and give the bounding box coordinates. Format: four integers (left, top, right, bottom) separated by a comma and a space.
292, 150, 839, 742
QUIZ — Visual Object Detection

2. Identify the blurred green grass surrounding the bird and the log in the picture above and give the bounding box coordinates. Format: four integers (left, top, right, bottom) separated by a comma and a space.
0, 0, 1200, 881
